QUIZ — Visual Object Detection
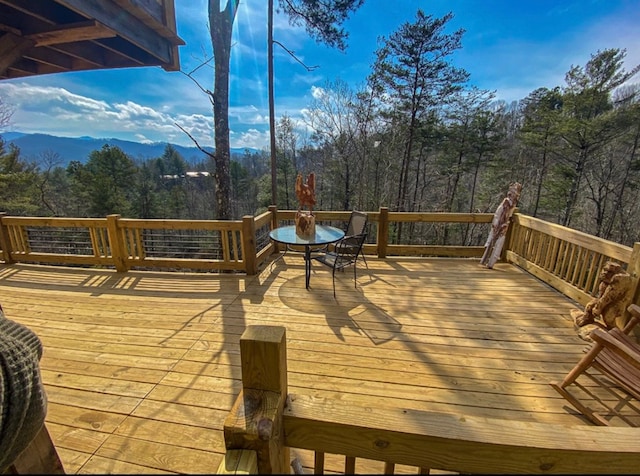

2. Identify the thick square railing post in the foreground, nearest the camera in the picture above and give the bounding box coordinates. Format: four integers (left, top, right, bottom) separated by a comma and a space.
224, 326, 289, 474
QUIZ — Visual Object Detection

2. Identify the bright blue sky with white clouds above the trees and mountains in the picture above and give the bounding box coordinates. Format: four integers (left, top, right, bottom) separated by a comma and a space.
0, 0, 640, 149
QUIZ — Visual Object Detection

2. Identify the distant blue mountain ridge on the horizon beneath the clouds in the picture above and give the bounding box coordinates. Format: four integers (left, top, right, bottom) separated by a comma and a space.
0, 132, 255, 167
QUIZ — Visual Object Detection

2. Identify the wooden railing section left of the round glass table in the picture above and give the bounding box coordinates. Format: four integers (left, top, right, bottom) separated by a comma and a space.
0, 215, 268, 274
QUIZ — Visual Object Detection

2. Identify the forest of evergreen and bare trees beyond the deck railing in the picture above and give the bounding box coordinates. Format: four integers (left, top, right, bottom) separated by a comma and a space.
0, 11, 640, 245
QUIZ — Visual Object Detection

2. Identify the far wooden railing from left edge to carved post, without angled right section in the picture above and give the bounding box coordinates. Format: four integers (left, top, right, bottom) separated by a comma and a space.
0, 207, 492, 274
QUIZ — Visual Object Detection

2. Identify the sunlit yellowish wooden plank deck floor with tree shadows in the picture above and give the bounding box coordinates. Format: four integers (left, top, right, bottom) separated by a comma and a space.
0, 254, 624, 474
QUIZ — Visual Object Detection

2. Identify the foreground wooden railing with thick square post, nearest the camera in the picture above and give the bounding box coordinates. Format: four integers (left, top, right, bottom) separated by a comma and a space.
218, 326, 640, 474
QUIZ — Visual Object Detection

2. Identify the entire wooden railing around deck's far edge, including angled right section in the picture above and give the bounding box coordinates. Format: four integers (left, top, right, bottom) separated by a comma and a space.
0, 207, 640, 305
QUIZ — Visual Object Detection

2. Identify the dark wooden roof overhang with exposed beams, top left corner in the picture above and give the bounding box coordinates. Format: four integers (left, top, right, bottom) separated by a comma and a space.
0, 0, 184, 79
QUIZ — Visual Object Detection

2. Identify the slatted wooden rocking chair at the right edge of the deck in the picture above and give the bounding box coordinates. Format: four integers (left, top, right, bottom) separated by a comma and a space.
550, 304, 640, 426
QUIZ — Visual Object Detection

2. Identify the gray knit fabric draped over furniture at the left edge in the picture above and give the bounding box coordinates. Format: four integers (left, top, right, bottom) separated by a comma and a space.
0, 308, 47, 473
